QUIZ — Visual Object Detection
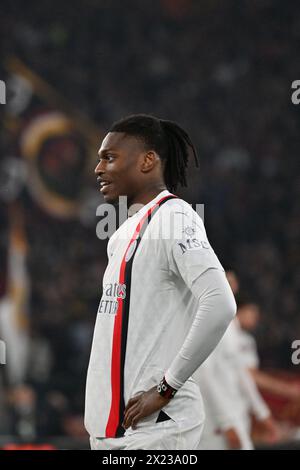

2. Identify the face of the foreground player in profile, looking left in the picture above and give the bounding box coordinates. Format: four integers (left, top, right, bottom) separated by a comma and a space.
95, 132, 145, 203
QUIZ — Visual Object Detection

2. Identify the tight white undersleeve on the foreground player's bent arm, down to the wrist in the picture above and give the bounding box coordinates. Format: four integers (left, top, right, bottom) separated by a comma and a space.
165, 269, 236, 390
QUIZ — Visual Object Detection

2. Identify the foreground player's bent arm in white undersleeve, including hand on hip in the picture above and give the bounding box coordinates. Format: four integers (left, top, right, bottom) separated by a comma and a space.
124, 269, 236, 429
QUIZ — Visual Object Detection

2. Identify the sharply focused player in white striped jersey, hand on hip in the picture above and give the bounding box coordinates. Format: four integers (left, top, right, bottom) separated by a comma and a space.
85, 115, 236, 450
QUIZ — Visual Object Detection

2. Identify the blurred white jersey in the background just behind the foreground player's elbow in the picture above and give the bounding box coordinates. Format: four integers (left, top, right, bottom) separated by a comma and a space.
194, 319, 270, 449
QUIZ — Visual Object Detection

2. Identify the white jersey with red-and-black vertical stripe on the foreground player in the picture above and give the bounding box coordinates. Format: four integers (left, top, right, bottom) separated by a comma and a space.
85, 190, 224, 438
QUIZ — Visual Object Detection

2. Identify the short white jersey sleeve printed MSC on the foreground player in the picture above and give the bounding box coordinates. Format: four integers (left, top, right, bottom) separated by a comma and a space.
167, 207, 224, 287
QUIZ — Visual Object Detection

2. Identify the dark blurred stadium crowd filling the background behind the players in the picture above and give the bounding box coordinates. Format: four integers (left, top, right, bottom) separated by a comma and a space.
0, 0, 300, 448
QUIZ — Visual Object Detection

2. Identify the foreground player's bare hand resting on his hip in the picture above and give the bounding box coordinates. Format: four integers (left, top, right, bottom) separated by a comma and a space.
122, 387, 170, 429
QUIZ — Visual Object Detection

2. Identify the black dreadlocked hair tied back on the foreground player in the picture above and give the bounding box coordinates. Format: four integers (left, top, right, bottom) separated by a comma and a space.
109, 114, 199, 192
